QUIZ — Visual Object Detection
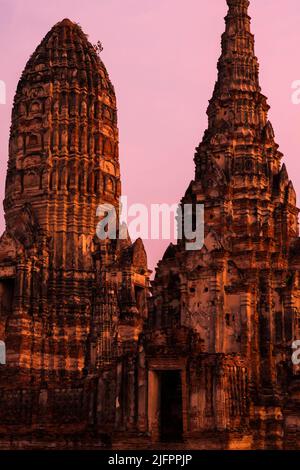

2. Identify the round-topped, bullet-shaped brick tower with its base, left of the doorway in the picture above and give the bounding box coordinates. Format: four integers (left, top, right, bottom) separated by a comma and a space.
0, 19, 148, 447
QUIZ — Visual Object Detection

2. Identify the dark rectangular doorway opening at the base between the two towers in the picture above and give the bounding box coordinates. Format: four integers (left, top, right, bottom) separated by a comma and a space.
160, 370, 183, 442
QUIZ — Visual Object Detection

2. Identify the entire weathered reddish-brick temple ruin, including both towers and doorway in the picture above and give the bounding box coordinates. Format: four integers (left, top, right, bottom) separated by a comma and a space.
0, 0, 300, 449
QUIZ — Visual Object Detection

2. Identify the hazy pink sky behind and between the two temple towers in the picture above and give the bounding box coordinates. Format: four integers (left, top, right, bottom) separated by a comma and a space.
0, 0, 300, 269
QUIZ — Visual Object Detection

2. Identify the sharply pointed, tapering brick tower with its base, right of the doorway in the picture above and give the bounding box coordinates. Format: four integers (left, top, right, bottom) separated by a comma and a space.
144, 0, 300, 449
